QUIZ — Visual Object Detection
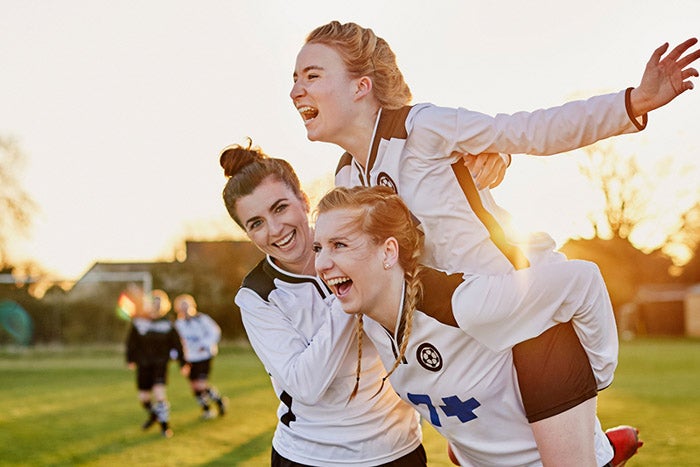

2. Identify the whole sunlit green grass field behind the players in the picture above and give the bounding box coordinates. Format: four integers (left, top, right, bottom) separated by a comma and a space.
0, 339, 700, 467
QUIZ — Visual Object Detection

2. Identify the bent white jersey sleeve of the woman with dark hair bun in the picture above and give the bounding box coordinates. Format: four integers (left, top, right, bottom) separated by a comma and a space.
236, 288, 355, 404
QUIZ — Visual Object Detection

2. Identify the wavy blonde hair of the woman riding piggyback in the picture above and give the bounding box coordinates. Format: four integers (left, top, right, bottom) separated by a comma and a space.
306, 21, 412, 109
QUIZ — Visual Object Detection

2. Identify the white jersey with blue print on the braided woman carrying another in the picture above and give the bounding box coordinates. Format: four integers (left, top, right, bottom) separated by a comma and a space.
358, 261, 613, 466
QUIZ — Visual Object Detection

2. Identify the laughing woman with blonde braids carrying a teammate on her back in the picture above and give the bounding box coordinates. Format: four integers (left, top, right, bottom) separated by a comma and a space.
314, 187, 626, 467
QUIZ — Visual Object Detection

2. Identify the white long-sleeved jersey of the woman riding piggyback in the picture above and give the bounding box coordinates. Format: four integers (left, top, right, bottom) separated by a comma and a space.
336, 89, 647, 389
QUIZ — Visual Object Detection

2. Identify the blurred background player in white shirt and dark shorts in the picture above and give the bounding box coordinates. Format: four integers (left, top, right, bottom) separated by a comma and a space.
173, 294, 226, 419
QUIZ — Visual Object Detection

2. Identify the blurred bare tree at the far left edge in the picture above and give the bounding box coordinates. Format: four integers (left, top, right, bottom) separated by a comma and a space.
0, 136, 37, 269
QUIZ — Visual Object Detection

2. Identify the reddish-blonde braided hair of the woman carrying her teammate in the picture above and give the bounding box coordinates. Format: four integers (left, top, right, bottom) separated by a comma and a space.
316, 186, 423, 399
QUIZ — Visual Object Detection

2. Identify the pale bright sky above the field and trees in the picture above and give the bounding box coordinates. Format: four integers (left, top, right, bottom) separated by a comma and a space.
0, 0, 700, 279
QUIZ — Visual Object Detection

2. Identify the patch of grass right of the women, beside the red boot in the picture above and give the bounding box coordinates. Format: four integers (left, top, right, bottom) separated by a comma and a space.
598, 339, 700, 466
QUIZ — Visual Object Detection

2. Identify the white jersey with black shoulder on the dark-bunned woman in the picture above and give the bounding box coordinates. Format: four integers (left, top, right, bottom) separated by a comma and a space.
235, 257, 421, 466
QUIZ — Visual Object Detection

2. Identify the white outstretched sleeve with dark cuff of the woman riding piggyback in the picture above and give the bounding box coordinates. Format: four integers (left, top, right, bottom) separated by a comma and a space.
410, 91, 646, 161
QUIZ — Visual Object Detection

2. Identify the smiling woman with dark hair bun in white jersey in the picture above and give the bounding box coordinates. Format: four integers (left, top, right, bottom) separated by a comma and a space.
220, 141, 427, 467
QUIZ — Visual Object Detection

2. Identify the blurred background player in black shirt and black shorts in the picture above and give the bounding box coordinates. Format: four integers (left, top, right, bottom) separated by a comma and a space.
126, 290, 185, 438
